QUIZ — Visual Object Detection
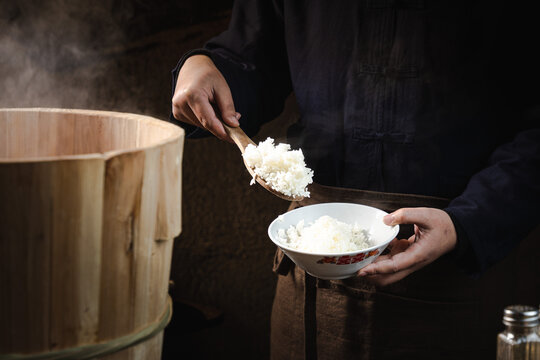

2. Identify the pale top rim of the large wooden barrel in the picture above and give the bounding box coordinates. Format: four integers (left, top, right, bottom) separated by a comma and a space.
0, 107, 185, 164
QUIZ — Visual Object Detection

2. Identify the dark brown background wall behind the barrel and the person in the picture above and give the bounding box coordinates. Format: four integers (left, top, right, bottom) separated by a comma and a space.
0, 0, 296, 359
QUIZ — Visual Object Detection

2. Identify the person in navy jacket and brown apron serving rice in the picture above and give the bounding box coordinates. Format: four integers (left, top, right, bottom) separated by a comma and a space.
171, 0, 540, 359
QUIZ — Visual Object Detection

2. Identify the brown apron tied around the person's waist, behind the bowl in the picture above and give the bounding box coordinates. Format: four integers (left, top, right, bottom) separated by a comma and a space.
271, 184, 540, 359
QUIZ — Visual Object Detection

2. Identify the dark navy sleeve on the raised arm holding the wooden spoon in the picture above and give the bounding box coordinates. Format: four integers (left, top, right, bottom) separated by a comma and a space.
170, 0, 292, 138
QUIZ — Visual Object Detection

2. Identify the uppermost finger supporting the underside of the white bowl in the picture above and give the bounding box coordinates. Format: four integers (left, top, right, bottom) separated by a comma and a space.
359, 240, 425, 276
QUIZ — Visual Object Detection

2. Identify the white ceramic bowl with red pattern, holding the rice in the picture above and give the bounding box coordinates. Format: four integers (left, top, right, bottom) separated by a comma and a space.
268, 203, 399, 280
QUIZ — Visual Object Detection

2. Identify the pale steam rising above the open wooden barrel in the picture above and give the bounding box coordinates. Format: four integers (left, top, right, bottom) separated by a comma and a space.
0, 0, 130, 108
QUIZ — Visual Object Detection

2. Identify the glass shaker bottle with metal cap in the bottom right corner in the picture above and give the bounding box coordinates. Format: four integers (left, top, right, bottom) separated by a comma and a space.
497, 305, 540, 360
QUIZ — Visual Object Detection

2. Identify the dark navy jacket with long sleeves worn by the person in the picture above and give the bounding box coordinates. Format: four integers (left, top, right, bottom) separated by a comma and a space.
171, 0, 540, 273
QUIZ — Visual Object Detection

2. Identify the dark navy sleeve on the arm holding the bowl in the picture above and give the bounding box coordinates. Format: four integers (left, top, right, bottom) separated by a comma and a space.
445, 128, 540, 275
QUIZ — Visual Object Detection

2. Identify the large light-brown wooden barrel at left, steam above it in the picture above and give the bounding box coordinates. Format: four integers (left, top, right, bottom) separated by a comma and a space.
0, 109, 184, 360
